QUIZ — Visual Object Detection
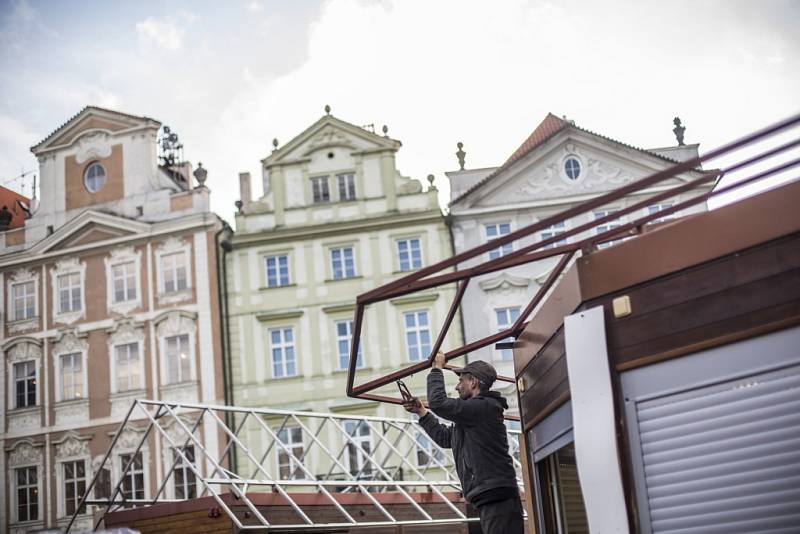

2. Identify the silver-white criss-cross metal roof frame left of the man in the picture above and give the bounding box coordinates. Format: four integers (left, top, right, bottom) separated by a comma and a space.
66, 400, 523, 532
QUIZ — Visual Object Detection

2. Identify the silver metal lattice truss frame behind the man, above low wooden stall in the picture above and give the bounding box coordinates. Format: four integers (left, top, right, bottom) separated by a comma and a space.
66, 400, 522, 532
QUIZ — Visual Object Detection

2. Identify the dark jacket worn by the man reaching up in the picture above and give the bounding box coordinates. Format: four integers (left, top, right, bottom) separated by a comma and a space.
419, 368, 517, 501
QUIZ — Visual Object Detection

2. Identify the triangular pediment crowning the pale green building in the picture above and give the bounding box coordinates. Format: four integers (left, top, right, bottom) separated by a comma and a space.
262, 115, 400, 167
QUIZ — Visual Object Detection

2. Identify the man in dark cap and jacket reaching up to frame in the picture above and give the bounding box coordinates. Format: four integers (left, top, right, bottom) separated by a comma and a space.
404, 352, 523, 534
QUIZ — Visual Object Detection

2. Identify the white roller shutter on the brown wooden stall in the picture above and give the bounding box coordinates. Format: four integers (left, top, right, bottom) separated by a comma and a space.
635, 366, 800, 534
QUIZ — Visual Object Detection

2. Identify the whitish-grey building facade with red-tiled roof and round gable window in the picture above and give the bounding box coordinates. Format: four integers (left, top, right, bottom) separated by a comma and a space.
446, 114, 713, 414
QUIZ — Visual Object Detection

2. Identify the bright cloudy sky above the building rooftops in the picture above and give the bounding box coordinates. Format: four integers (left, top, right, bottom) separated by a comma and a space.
0, 0, 800, 220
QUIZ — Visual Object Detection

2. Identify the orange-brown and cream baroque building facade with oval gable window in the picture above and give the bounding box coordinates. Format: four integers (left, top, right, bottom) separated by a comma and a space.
0, 107, 223, 533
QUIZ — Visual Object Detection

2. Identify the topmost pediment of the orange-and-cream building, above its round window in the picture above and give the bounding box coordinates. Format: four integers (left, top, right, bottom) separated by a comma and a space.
31, 106, 161, 154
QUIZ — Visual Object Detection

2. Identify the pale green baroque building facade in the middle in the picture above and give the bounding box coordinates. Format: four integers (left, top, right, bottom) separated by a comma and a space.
226, 109, 461, 473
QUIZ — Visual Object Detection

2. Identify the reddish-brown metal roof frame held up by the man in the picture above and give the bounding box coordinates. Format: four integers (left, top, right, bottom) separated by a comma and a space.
347, 115, 800, 406
